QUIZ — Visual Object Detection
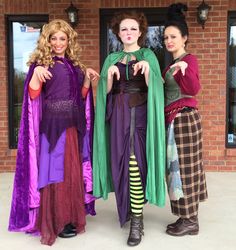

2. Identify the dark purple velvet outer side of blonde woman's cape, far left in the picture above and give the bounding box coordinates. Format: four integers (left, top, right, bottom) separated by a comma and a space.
9, 65, 38, 231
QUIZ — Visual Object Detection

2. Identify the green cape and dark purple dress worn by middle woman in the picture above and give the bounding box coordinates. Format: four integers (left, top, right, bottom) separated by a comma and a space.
93, 48, 165, 226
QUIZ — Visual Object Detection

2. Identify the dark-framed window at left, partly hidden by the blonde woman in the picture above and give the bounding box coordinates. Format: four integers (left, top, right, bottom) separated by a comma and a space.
6, 15, 48, 148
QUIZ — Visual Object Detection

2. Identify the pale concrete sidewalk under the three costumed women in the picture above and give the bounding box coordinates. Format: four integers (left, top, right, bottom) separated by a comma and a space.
0, 172, 236, 250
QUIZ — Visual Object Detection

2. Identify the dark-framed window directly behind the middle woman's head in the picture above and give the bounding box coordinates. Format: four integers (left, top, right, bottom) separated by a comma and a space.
100, 8, 171, 70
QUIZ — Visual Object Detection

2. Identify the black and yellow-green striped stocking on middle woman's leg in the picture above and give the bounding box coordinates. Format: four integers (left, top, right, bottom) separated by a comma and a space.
129, 154, 144, 216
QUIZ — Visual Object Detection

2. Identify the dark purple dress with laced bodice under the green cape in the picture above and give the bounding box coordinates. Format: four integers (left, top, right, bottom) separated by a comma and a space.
107, 61, 147, 226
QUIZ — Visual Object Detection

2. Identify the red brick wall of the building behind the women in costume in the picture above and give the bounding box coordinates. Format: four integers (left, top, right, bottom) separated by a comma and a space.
0, 0, 236, 172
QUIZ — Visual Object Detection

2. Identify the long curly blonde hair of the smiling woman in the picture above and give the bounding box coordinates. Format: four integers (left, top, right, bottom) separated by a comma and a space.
27, 19, 85, 69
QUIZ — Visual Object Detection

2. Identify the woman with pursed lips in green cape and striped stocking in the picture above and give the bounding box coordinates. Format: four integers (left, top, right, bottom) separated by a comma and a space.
93, 11, 165, 246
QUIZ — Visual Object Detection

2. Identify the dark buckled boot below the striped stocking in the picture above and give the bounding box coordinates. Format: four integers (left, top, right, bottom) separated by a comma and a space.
127, 214, 144, 246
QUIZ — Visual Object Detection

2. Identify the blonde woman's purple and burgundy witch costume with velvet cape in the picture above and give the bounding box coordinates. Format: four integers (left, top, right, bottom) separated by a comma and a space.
9, 57, 95, 245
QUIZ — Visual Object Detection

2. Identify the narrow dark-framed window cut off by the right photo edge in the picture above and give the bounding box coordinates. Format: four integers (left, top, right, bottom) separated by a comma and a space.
226, 12, 236, 147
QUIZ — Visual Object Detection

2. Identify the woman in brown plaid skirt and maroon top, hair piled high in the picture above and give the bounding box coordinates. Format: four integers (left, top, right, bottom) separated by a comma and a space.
163, 4, 207, 236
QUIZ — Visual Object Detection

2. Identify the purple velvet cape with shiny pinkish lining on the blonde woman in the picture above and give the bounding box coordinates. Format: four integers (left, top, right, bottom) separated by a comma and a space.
8, 65, 95, 232
